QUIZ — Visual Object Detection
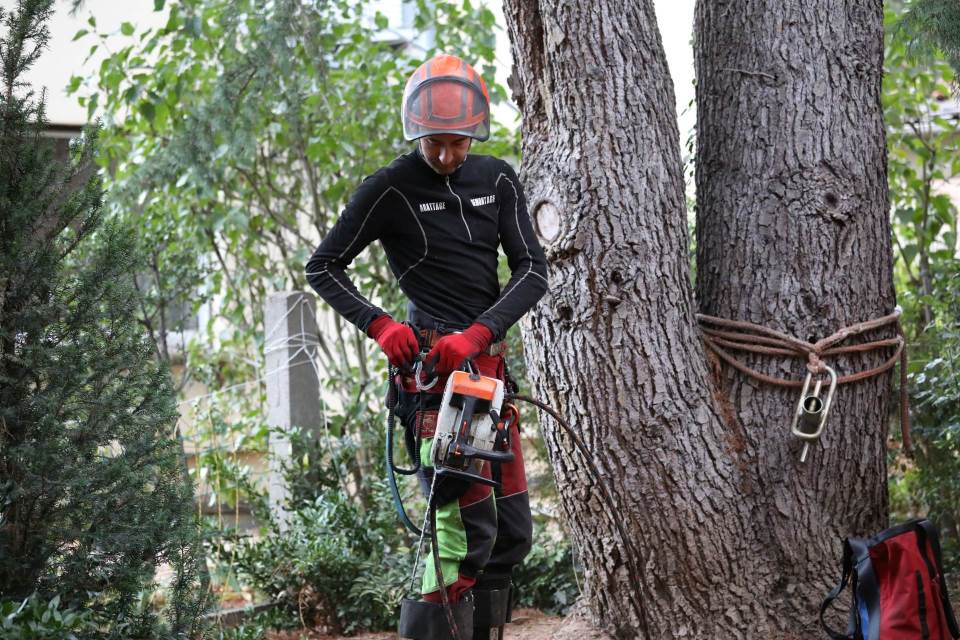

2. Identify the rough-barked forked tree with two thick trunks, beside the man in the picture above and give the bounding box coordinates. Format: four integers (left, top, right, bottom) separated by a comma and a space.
504, 0, 893, 638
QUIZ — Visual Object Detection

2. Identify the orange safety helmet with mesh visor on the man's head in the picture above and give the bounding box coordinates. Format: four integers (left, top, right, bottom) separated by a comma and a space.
400, 53, 490, 141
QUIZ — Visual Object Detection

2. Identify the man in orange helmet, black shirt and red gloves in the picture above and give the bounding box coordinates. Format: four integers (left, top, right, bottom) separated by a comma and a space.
306, 55, 547, 640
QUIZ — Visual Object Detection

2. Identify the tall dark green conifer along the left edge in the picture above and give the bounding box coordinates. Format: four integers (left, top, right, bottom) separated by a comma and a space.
0, 0, 209, 638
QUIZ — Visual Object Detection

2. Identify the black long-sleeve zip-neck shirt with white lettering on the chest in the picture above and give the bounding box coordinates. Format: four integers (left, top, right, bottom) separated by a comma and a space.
306, 149, 547, 340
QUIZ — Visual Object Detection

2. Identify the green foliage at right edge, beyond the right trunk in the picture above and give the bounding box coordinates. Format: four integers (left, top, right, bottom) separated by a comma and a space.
883, 0, 960, 572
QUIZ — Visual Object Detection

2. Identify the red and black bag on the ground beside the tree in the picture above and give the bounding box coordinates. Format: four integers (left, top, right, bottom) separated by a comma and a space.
820, 519, 960, 640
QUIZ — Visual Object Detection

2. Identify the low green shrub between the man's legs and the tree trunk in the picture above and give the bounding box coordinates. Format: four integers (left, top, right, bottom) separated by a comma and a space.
513, 524, 580, 615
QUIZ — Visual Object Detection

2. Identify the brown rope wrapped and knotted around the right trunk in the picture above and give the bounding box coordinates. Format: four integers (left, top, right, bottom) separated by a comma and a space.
696, 307, 911, 452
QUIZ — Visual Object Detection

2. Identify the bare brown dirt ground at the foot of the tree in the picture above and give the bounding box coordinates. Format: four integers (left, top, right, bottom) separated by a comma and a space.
267, 609, 610, 640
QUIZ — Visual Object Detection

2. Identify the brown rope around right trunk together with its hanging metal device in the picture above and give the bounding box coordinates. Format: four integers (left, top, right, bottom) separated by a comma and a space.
696, 307, 911, 462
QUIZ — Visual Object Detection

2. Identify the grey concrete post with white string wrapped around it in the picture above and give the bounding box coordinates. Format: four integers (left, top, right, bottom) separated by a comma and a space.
264, 291, 320, 531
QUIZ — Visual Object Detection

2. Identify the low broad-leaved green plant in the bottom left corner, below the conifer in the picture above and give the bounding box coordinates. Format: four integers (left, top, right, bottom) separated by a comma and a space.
0, 594, 96, 640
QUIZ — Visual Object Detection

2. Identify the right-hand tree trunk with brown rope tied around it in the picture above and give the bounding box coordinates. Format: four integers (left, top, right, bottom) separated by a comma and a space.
695, 0, 895, 621
